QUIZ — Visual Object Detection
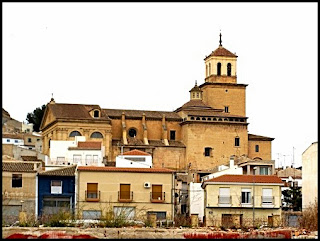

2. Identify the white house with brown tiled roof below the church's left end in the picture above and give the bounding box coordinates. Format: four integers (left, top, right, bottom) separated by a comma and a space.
46, 136, 105, 170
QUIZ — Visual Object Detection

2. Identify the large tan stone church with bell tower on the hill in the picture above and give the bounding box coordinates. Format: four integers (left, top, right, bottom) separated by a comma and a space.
40, 34, 274, 177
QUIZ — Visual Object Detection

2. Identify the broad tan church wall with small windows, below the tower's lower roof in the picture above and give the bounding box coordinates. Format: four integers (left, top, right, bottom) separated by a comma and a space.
182, 123, 248, 170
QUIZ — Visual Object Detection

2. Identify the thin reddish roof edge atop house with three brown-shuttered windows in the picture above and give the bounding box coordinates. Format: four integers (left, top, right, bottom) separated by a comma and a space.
78, 166, 174, 173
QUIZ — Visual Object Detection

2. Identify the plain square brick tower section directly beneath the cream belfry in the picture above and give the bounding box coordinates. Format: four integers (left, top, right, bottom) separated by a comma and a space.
202, 85, 246, 116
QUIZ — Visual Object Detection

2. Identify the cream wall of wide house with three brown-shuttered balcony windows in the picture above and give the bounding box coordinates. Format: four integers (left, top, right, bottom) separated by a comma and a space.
77, 171, 173, 219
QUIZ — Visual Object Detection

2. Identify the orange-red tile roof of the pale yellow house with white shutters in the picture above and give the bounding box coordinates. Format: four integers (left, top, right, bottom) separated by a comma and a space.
205, 175, 283, 184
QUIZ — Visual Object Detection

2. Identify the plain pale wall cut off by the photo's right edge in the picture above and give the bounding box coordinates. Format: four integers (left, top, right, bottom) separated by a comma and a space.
302, 142, 318, 210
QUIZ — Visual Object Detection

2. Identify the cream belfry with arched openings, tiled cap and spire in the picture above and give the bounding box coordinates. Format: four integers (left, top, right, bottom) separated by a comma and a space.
204, 33, 238, 83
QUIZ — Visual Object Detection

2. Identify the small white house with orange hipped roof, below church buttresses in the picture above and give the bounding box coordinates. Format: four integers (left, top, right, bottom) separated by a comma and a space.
116, 149, 152, 168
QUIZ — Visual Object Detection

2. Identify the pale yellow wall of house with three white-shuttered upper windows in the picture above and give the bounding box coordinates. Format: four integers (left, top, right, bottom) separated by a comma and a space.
205, 184, 281, 226
